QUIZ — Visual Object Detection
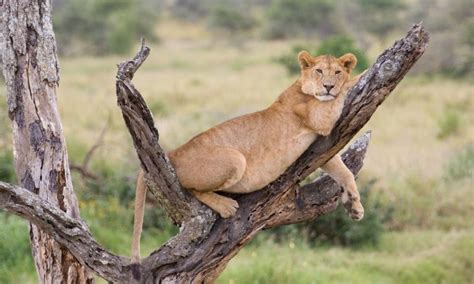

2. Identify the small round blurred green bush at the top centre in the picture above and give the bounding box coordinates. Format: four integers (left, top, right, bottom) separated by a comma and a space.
209, 3, 256, 34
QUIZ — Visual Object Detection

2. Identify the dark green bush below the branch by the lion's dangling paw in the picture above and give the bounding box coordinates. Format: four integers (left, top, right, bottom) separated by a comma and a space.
270, 181, 394, 247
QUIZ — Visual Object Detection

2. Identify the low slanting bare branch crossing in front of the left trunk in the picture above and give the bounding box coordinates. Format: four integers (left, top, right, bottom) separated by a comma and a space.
0, 181, 132, 283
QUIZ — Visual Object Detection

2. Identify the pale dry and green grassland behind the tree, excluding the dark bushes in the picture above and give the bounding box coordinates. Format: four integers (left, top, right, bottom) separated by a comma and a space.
0, 19, 474, 283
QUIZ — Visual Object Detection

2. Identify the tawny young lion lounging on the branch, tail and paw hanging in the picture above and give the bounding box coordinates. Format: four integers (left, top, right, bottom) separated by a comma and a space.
132, 51, 364, 261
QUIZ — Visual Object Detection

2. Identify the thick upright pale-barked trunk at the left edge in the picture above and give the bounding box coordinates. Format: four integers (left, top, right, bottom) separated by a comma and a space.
0, 0, 93, 283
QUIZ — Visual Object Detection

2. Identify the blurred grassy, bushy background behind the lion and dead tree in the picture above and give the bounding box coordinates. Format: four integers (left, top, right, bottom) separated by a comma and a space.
0, 0, 474, 283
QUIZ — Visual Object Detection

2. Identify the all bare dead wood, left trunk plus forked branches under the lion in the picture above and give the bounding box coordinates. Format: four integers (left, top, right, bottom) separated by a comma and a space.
0, 0, 428, 283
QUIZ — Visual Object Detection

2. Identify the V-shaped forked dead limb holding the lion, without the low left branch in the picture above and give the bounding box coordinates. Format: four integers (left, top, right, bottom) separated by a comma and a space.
116, 25, 429, 282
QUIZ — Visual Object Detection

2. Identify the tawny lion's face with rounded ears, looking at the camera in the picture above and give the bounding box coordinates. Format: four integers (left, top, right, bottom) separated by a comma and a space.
298, 51, 357, 101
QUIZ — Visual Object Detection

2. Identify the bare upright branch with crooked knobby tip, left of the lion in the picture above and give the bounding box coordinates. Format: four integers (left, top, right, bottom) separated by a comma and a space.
116, 43, 215, 224
